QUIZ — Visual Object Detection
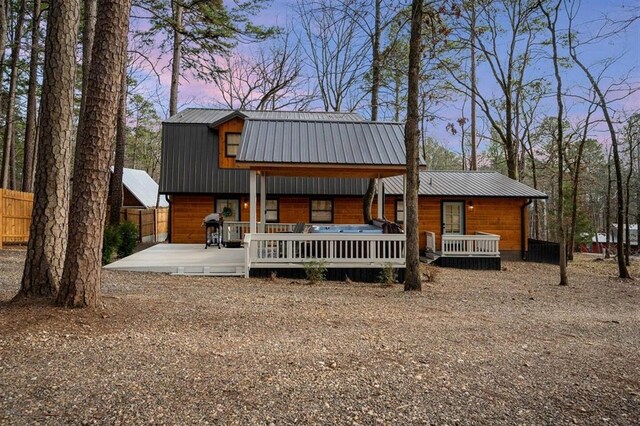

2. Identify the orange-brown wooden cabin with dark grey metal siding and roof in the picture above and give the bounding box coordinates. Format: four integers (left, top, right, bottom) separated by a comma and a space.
160, 109, 546, 269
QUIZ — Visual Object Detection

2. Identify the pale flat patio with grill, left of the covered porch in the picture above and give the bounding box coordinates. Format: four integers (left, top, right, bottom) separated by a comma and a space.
104, 244, 244, 276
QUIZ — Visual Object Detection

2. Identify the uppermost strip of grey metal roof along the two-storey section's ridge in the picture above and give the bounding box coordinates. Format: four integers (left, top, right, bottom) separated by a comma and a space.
164, 108, 363, 125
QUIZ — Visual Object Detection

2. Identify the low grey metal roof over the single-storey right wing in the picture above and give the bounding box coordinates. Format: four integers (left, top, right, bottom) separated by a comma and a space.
384, 171, 547, 198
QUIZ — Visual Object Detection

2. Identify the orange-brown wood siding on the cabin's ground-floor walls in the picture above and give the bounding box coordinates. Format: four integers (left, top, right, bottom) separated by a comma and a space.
171, 195, 526, 251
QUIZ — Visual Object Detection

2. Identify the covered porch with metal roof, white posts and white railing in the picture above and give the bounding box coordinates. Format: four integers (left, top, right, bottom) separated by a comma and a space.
236, 120, 406, 279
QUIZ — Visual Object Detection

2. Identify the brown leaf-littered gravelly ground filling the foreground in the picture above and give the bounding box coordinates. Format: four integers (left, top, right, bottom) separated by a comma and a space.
0, 250, 640, 425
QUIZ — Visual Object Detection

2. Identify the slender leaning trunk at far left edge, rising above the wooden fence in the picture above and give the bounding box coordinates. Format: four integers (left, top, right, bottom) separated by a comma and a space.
2, 0, 26, 189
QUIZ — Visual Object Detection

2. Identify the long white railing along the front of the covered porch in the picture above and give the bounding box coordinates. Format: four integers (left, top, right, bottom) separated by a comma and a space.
244, 233, 406, 277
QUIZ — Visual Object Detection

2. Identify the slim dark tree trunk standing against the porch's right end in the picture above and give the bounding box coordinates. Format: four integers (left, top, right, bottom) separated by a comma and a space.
404, 0, 423, 291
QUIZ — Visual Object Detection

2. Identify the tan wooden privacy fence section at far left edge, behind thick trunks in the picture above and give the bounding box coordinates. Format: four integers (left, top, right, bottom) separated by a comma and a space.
0, 189, 33, 248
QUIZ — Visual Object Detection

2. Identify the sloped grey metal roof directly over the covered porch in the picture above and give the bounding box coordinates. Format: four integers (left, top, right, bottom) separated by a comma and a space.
236, 119, 405, 166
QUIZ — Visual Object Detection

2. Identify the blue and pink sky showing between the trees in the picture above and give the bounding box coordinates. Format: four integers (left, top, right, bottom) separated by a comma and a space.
132, 0, 640, 156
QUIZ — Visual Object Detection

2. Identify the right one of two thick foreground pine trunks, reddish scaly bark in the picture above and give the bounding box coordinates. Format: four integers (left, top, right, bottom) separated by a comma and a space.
58, 0, 131, 308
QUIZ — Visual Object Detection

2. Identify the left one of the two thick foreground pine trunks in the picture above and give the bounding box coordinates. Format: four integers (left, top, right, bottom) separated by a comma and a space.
18, 0, 80, 297
